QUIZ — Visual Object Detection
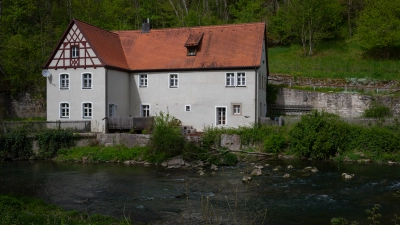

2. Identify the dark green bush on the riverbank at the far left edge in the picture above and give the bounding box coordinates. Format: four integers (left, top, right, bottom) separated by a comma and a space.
0, 129, 32, 159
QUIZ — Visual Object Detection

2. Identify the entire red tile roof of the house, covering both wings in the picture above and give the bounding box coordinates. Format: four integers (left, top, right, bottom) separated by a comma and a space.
44, 19, 265, 71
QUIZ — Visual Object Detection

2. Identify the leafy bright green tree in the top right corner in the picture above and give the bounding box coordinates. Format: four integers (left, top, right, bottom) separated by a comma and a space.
357, 0, 400, 59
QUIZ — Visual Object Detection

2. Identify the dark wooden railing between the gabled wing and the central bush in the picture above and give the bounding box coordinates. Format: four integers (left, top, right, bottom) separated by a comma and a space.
107, 117, 154, 130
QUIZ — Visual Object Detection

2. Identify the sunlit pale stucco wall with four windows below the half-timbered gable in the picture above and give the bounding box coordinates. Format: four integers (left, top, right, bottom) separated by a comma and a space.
43, 67, 106, 132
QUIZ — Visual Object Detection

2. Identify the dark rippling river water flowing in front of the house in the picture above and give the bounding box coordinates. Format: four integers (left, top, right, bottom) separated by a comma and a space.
0, 160, 400, 225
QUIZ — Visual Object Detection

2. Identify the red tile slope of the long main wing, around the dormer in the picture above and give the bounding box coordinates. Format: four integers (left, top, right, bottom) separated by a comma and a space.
115, 23, 265, 71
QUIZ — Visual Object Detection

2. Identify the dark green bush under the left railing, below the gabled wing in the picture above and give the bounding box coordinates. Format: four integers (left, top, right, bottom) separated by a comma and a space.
35, 129, 75, 159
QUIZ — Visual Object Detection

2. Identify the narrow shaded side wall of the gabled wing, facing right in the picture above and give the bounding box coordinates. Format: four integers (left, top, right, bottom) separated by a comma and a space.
107, 70, 130, 117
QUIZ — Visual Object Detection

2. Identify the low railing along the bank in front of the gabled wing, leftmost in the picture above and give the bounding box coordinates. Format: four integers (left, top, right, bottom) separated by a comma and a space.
2, 121, 91, 133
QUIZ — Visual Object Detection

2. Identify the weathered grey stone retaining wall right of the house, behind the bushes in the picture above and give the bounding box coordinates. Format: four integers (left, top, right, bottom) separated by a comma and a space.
276, 88, 400, 118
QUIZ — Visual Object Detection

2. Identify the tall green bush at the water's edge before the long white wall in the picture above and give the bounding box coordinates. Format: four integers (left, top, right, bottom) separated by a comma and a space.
148, 112, 185, 162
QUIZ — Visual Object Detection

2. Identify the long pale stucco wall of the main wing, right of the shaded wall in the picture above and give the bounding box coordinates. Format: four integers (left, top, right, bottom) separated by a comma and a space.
130, 69, 258, 131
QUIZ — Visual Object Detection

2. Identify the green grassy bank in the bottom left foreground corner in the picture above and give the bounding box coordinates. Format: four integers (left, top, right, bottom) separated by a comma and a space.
0, 195, 127, 225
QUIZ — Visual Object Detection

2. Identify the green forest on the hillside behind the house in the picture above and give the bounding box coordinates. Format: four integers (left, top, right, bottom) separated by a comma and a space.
0, 0, 400, 94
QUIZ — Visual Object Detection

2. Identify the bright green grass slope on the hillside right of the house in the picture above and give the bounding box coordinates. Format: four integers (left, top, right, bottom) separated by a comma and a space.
268, 40, 400, 80
